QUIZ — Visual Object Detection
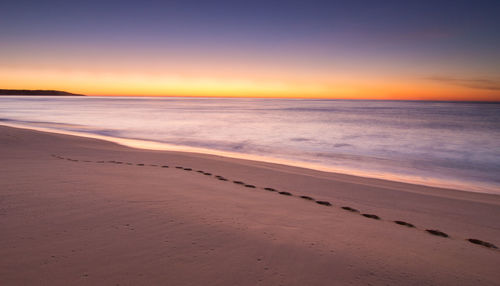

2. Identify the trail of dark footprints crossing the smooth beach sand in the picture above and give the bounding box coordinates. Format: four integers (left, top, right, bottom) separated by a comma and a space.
51, 154, 498, 249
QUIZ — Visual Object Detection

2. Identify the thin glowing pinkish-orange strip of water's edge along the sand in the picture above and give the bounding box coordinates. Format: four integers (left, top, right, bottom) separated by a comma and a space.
0, 122, 500, 195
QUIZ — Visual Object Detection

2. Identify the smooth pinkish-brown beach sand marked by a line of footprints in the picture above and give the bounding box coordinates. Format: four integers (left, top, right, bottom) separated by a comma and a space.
0, 126, 500, 285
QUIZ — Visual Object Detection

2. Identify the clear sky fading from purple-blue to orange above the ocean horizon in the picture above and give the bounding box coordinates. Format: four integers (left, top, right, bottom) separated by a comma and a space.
0, 0, 500, 101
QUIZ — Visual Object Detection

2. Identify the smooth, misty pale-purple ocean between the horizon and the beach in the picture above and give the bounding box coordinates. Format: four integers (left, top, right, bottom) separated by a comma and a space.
0, 96, 500, 194
